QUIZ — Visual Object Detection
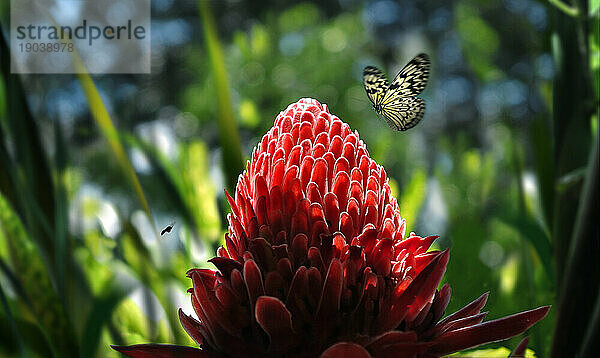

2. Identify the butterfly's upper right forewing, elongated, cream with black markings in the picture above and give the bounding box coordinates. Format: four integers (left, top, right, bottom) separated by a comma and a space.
381, 53, 430, 105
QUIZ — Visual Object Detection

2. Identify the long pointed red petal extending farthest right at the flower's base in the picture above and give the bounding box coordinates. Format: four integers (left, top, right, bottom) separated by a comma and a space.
429, 306, 550, 355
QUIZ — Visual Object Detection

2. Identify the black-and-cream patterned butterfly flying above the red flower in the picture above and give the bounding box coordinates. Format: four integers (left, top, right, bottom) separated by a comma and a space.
363, 53, 430, 131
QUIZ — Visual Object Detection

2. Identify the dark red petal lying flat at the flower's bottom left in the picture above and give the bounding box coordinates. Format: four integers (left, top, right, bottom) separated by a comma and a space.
111, 344, 213, 358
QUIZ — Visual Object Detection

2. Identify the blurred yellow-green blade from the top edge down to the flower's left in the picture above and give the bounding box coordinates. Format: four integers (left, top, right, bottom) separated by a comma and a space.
198, 0, 244, 191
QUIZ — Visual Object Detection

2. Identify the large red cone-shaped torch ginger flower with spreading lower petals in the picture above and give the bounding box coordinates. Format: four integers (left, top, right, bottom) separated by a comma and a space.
114, 99, 549, 358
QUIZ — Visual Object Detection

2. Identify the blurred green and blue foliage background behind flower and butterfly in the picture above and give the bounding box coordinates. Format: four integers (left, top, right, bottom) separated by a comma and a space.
0, 0, 600, 357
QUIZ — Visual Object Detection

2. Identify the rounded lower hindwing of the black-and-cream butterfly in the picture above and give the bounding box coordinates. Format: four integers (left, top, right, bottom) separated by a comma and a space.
381, 96, 425, 131
